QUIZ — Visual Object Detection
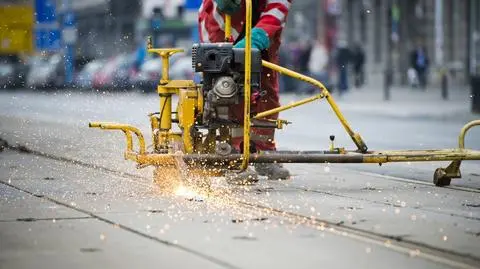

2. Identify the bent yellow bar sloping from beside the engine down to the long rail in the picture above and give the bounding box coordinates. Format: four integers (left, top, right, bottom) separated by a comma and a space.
262, 60, 367, 152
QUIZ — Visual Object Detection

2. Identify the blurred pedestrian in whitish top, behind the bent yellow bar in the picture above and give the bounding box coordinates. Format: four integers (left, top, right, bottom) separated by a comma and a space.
308, 39, 329, 93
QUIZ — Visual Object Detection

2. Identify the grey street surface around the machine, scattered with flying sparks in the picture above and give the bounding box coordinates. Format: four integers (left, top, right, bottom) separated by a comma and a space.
0, 91, 480, 268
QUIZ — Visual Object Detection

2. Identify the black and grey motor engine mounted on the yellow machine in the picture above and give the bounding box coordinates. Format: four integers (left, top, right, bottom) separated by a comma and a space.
192, 43, 262, 127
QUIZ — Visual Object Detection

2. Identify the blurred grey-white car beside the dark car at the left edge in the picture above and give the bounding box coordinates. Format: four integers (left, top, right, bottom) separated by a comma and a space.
26, 54, 65, 88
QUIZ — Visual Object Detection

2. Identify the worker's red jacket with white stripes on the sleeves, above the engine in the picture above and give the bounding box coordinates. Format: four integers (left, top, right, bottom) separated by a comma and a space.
198, 0, 291, 57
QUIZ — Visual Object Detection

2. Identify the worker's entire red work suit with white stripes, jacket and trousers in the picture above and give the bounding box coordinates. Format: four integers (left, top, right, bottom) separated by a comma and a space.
198, 0, 291, 150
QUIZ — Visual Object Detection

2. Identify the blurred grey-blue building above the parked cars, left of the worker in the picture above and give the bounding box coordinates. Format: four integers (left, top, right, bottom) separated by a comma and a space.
70, 0, 191, 57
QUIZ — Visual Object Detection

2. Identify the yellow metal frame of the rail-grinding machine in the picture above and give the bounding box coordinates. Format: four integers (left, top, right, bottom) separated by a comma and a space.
89, 0, 480, 186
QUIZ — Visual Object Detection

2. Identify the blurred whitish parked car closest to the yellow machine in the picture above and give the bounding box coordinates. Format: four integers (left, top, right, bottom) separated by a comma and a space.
130, 58, 162, 91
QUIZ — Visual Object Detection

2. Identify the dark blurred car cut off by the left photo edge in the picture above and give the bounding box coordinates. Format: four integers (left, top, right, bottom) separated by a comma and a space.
0, 55, 28, 88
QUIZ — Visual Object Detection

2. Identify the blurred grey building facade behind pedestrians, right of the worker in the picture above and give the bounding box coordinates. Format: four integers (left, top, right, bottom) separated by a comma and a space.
287, 0, 480, 86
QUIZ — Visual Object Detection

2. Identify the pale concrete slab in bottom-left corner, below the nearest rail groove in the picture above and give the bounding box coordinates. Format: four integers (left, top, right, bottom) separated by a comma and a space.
0, 220, 228, 268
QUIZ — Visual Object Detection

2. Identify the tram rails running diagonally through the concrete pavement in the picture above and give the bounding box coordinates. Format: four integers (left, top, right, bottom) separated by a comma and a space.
0, 140, 480, 269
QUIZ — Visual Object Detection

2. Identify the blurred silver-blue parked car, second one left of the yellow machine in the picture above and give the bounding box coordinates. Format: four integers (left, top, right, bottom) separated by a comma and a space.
93, 54, 134, 89
